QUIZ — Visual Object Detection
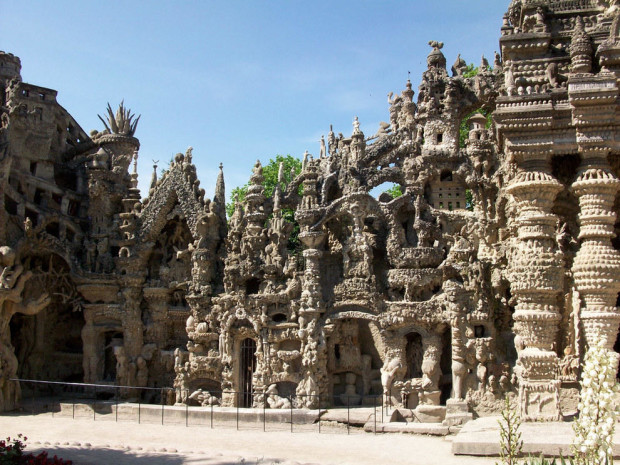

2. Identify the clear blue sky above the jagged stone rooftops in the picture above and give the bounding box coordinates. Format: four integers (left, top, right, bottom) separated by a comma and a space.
0, 0, 509, 201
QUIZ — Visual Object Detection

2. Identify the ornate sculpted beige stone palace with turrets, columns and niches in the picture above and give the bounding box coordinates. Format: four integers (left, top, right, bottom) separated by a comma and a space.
0, 0, 620, 422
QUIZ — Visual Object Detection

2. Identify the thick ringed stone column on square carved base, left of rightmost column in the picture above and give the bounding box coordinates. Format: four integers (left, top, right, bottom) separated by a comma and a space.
507, 150, 563, 420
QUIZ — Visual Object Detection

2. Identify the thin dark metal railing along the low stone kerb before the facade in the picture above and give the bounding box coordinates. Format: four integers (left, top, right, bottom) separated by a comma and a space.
11, 379, 390, 434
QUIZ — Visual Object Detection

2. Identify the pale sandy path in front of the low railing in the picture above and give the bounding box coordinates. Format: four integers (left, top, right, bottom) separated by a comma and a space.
0, 414, 496, 465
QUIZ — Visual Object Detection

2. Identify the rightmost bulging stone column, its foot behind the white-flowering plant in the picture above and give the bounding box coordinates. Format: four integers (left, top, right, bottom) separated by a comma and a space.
569, 74, 620, 351
